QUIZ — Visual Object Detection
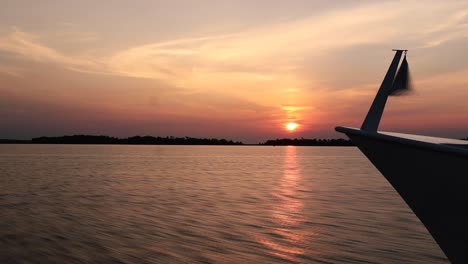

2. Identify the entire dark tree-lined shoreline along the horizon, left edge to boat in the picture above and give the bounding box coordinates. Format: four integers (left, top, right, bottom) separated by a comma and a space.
0, 135, 354, 147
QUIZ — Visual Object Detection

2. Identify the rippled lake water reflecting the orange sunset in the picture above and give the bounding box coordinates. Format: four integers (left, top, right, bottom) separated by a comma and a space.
0, 145, 448, 263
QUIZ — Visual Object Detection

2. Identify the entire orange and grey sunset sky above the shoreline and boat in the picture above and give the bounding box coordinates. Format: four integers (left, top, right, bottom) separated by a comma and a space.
0, 0, 468, 143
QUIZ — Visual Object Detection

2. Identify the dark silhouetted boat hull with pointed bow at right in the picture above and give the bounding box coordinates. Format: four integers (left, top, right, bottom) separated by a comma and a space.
337, 128, 468, 263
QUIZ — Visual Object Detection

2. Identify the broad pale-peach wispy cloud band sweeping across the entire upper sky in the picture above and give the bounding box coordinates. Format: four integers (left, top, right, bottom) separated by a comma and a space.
0, 1, 468, 85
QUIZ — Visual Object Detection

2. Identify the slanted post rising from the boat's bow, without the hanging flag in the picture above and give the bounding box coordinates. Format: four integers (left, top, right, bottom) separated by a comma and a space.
361, 49, 408, 132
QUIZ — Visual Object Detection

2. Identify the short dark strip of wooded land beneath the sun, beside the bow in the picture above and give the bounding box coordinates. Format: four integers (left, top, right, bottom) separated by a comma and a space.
260, 138, 354, 146
